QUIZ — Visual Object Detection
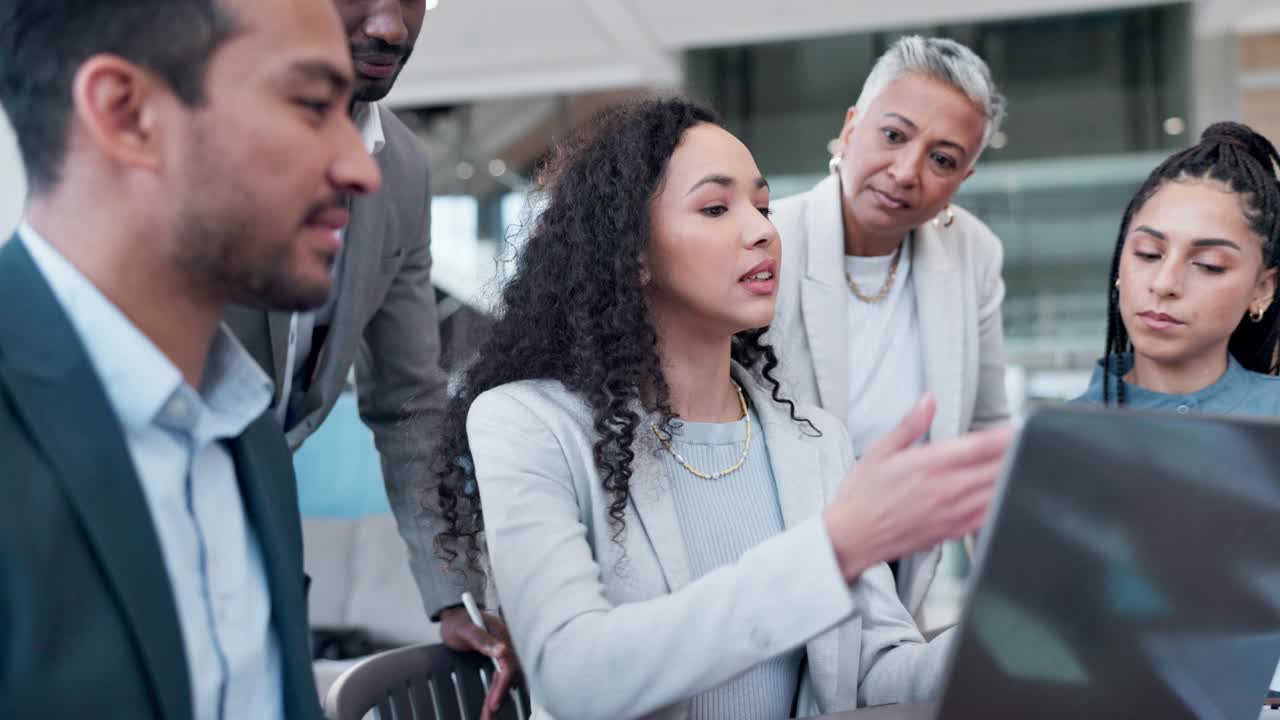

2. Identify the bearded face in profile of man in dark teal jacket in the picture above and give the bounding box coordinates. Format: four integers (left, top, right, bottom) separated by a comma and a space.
167, 0, 380, 310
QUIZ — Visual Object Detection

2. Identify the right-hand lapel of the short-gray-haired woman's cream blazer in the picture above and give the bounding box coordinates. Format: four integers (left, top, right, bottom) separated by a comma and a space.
911, 223, 964, 441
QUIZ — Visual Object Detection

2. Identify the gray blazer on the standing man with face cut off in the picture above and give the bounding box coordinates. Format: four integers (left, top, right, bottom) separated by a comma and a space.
227, 108, 481, 615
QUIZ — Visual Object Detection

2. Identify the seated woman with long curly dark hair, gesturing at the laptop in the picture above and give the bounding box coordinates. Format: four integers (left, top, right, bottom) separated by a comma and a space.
438, 99, 1009, 719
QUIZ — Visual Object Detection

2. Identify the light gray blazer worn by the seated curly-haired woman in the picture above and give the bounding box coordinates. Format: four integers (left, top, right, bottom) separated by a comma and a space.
467, 368, 948, 720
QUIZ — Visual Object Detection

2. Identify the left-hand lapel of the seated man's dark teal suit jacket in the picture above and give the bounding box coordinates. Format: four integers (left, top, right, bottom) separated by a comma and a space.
0, 240, 192, 720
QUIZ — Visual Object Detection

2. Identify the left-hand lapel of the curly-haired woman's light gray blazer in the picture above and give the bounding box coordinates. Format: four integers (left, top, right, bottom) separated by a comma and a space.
631, 419, 690, 592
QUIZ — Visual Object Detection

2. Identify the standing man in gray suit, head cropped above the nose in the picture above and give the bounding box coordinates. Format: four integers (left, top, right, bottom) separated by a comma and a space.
227, 0, 515, 698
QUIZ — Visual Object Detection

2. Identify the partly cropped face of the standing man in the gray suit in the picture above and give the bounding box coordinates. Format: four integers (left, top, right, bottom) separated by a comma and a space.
334, 0, 426, 102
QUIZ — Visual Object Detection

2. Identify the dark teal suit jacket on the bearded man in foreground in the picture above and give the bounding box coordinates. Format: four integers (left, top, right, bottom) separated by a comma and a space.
0, 240, 321, 720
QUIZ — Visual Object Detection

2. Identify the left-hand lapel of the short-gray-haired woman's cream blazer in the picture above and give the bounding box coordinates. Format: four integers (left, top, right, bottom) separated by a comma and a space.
800, 174, 849, 420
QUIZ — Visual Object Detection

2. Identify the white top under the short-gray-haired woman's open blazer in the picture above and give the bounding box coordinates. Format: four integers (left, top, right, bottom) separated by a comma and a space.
845, 236, 924, 457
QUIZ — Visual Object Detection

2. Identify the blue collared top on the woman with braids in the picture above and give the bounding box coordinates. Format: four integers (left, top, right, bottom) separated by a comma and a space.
1073, 352, 1280, 416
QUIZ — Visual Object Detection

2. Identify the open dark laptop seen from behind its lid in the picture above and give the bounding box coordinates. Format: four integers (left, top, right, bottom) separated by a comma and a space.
932, 406, 1280, 720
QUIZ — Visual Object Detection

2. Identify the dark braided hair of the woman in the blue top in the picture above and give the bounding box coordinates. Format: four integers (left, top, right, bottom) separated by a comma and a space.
1102, 123, 1280, 405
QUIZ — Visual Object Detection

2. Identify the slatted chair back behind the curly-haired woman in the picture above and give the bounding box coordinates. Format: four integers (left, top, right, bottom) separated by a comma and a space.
324, 644, 529, 720
